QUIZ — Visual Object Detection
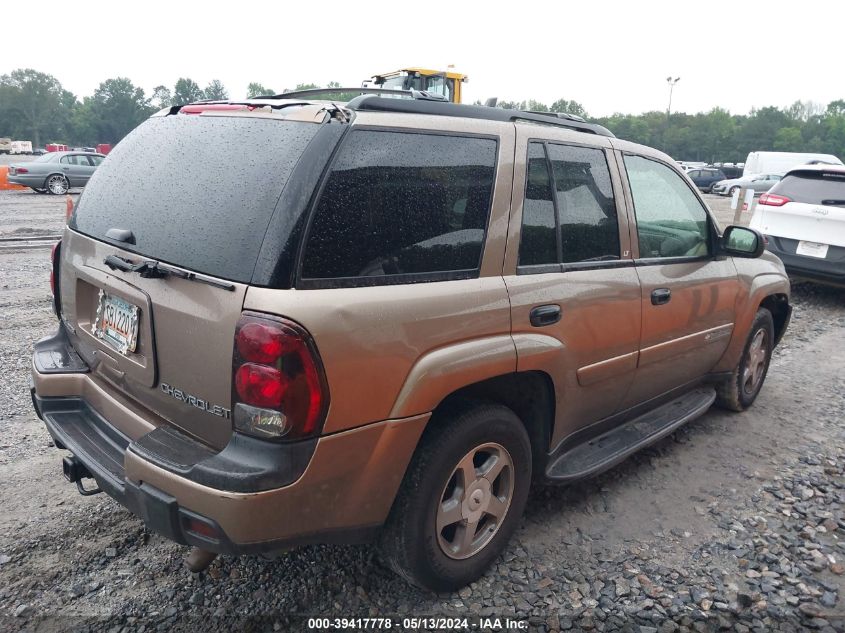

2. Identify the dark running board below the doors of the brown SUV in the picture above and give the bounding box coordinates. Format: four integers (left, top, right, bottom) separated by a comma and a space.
546, 387, 716, 483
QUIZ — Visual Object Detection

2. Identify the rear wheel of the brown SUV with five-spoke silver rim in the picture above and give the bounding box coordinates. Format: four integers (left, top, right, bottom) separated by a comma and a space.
381, 400, 531, 592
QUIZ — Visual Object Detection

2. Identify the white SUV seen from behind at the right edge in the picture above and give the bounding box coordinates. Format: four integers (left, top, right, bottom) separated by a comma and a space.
751, 165, 845, 286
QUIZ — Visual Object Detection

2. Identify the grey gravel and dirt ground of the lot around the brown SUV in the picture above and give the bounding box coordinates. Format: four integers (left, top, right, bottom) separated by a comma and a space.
0, 192, 845, 633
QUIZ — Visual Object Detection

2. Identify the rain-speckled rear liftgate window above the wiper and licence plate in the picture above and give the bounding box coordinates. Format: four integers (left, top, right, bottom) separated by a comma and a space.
71, 115, 320, 283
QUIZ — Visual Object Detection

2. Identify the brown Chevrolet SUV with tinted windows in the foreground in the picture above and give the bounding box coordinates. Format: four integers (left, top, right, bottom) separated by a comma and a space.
32, 93, 790, 591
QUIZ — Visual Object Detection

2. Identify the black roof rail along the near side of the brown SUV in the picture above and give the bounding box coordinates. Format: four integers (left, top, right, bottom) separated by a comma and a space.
346, 91, 613, 137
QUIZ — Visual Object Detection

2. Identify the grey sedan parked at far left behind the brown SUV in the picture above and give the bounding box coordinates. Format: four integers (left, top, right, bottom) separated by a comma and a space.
9, 152, 105, 196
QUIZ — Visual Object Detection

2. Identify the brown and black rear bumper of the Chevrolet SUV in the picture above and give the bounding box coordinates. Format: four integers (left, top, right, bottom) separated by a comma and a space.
32, 329, 429, 554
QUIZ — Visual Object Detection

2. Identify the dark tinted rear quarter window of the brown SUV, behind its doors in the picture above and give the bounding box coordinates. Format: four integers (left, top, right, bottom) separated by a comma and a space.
299, 130, 497, 288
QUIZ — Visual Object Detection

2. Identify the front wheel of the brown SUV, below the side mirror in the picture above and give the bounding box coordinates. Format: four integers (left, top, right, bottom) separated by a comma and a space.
716, 308, 775, 411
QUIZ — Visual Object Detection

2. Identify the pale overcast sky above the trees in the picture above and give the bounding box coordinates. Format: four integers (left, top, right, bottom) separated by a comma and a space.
0, 0, 845, 116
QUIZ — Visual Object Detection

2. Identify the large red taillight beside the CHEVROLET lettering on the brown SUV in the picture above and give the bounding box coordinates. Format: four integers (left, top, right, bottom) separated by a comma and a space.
232, 312, 328, 440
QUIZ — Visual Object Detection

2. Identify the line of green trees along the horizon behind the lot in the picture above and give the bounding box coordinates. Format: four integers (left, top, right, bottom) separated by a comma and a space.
0, 68, 845, 162
